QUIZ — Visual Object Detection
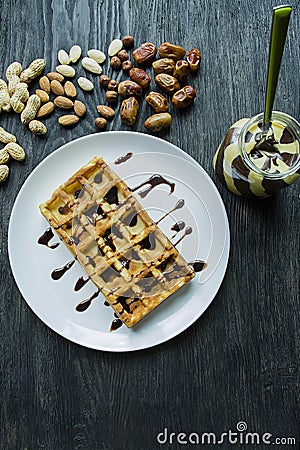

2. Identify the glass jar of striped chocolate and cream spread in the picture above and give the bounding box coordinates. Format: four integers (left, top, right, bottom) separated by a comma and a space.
214, 111, 300, 198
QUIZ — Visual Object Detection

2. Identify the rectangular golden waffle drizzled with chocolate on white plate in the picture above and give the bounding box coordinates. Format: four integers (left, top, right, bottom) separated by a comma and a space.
40, 157, 195, 327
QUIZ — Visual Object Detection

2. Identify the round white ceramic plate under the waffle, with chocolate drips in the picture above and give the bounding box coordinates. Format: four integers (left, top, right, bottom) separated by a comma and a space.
8, 131, 229, 352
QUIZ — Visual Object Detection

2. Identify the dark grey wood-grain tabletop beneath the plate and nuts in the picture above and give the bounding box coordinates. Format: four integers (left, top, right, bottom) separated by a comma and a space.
0, 0, 300, 450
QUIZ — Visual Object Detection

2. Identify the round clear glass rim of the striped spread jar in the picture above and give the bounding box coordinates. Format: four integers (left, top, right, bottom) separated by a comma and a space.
239, 111, 300, 179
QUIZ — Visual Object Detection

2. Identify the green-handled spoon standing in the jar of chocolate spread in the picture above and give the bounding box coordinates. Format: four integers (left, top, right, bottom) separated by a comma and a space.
263, 5, 292, 132
